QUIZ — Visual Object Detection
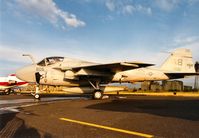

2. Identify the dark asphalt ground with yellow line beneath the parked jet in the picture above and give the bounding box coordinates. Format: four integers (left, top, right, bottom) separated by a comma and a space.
0, 95, 199, 138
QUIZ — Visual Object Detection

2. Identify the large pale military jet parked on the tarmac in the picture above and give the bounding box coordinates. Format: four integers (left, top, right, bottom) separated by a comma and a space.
16, 48, 196, 99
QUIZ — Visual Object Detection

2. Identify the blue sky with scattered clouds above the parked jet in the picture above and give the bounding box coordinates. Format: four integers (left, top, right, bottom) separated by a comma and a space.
0, 0, 199, 85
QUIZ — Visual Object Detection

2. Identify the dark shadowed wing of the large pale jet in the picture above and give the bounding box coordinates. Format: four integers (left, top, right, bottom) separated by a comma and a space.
62, 62, 154, 73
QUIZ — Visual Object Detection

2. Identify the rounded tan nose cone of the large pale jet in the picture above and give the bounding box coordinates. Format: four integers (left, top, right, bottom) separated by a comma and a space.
16, 65, 35, 82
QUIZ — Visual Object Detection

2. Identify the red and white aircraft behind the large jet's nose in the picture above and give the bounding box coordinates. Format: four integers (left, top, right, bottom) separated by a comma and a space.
0, 74, 28, 94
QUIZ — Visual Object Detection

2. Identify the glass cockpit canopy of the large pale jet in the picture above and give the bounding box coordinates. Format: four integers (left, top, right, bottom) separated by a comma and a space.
37, 57, 64, 66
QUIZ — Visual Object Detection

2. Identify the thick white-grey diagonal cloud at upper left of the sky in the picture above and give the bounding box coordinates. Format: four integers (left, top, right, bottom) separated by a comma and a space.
16, 0, 86, 27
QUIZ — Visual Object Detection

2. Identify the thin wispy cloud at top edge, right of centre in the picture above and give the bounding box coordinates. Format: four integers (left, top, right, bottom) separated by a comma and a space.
105, 0, 152, 15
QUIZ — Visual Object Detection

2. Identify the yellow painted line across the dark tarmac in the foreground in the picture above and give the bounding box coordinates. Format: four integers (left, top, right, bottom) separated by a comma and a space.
59, 118, 154, 138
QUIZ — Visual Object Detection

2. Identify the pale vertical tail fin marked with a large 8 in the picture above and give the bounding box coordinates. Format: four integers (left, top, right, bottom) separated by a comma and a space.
160, 48, 195, 73
